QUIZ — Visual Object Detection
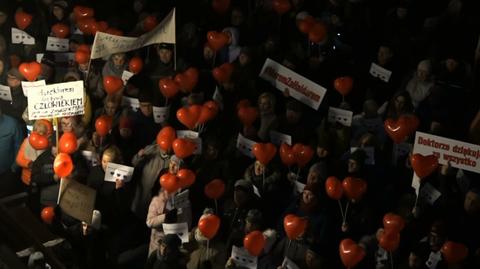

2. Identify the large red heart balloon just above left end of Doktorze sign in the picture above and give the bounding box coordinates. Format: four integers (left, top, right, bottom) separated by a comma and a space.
384, 115, 420, 144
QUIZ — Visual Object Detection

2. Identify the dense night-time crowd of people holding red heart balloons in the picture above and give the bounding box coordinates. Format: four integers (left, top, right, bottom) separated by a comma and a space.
0, 0, 480, 269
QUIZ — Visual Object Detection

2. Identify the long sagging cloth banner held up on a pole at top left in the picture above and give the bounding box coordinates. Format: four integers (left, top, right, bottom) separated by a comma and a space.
90, 9, 175, 59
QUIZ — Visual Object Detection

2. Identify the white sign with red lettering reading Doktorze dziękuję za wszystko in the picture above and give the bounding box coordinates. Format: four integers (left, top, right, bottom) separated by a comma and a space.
413, 132, 480, 173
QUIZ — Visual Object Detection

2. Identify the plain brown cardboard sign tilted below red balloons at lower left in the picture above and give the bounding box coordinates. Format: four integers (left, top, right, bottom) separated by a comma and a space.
58, 179, 96, 224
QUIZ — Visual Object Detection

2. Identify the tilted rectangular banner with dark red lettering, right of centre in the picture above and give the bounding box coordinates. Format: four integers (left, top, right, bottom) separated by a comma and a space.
260, 58, 327, 109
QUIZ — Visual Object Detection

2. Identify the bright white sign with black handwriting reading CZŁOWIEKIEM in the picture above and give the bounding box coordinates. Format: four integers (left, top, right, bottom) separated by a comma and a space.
27, 80, 85, 120
